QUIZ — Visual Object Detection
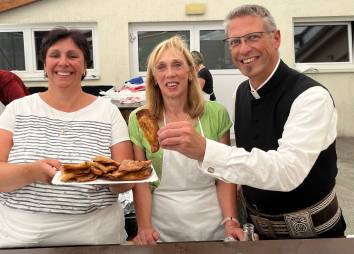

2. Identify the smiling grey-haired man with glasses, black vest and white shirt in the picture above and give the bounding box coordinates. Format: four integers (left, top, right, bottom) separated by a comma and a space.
159, 5, 346, 239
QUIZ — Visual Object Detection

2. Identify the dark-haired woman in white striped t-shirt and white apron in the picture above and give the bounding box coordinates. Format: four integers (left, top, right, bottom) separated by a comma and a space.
0, 28, 133, 248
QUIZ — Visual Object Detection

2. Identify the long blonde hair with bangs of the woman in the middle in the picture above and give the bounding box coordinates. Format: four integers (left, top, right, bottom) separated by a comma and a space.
145, 36, 204, 119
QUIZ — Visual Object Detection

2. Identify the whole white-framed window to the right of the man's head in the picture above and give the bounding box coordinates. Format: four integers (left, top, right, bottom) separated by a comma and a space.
294, 21, 354, 72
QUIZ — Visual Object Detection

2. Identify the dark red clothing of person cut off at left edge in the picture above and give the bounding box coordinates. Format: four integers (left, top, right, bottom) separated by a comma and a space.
0, 70, 29, 106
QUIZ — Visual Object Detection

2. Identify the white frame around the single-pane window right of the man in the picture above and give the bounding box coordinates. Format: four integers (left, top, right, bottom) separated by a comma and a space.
292, 17, 354, 73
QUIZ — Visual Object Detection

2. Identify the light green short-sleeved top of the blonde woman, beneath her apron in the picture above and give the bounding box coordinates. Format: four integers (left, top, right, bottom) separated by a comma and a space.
129, 101, 232, 187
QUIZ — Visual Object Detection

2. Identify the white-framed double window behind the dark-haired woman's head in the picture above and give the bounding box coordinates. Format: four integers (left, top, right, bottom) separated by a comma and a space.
0, 24, 98, 81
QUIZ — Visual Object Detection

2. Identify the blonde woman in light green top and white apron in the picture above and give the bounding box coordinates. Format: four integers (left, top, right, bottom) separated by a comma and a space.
129, 36, 242, 244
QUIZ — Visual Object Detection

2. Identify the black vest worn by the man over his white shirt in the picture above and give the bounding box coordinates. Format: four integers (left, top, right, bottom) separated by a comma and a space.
235, 61, 337, 215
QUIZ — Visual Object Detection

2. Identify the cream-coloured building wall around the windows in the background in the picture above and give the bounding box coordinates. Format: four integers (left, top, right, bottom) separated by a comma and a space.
0, 0, 354, 136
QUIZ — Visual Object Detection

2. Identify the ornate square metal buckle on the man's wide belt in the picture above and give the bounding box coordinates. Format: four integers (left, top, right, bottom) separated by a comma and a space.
284, 210, 317, 238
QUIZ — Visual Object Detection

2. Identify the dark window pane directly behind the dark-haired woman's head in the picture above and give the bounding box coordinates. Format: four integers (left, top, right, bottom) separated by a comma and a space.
34, 30, 94, 70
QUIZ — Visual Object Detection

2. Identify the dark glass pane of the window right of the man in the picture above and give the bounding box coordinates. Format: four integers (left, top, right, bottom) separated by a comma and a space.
294, 25, 349, 63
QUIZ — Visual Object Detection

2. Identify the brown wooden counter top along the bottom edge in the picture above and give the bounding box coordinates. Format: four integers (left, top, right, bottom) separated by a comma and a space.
0, 238, 354, 254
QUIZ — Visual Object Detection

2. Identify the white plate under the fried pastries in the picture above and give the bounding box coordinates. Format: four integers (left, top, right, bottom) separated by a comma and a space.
52, 167, 159, 185
